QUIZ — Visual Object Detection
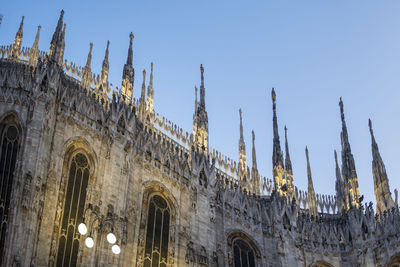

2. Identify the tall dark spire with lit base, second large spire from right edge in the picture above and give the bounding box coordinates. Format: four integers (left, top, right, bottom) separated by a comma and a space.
339, 98, 360, 208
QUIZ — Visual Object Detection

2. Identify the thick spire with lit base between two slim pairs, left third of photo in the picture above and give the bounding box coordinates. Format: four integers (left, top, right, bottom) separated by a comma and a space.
121, 33, 135, 103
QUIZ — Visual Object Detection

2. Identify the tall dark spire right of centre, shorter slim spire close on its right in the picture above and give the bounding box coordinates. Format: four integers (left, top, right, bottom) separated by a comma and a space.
271, 88, 286, 194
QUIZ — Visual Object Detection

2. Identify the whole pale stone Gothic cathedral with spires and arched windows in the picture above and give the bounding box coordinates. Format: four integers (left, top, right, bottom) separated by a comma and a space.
0, 11, 400, 267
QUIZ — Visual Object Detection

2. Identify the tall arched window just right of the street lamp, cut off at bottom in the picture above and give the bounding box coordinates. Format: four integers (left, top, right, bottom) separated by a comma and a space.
144, 195, 170, 267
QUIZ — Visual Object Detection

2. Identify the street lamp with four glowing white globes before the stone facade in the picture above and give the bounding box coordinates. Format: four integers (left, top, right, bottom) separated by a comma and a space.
78, 203, 121, 255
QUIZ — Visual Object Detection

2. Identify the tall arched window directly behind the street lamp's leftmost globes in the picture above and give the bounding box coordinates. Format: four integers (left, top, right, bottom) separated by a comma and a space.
57, 153, 90, 266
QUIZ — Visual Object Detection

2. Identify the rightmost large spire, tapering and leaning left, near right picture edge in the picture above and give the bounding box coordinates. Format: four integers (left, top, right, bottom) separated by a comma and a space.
368, 120, 395, 213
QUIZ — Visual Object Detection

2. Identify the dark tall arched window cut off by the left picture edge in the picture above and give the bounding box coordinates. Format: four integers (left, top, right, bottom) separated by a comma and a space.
0, 124, 20, 265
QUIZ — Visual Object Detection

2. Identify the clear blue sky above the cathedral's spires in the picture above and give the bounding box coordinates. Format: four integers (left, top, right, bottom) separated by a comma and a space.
0, 0, 400, 206
